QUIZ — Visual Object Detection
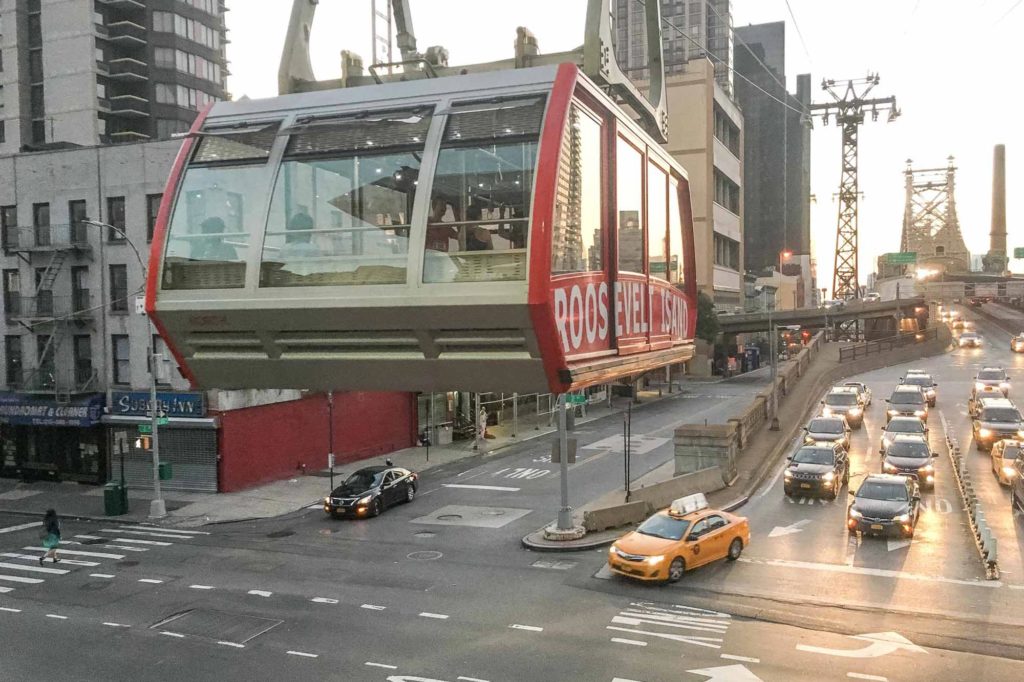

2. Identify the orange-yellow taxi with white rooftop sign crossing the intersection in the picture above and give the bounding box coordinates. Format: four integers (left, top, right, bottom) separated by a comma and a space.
608, 493, 751, 583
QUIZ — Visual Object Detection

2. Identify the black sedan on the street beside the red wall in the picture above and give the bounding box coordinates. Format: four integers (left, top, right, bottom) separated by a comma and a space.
324, 462, 419, 518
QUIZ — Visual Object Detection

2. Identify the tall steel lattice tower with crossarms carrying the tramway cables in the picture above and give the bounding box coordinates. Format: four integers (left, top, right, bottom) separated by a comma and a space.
811, 74, 900, 300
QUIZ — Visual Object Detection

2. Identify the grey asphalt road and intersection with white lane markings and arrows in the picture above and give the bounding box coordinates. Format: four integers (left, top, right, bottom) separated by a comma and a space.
0, 323, 1024, 682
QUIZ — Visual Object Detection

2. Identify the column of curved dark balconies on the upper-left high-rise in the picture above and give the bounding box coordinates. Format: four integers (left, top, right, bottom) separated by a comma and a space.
95, 0, 151, 142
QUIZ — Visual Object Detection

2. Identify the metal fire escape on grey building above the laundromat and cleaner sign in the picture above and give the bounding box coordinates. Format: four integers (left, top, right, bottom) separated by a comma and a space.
3, 211, 98, 403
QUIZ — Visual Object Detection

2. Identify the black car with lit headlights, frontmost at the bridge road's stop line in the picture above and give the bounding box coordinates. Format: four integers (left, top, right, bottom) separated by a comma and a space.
846, 474, 921, 538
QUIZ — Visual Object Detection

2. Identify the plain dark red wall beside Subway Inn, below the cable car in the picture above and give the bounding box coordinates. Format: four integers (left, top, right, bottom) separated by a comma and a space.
217, 392, 417, 493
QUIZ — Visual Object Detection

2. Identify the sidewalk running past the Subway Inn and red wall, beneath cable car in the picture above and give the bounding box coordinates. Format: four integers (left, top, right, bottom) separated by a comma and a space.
0, 378, 737, 527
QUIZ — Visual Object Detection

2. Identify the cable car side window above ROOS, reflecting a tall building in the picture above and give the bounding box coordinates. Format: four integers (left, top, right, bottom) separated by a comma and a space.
551, 103, 604, 273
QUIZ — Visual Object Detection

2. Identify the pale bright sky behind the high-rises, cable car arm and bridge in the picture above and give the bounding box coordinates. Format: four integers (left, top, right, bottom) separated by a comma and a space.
227, 0, 1024, 289
